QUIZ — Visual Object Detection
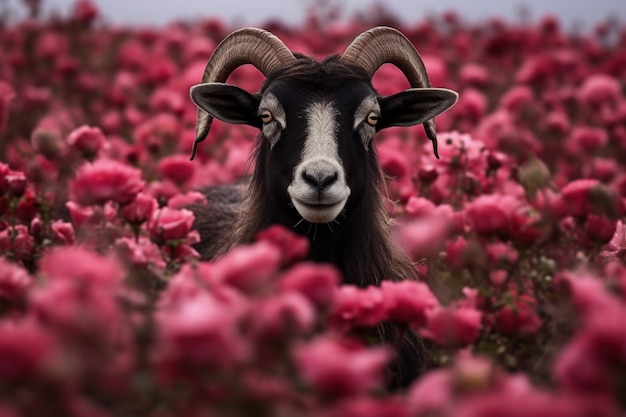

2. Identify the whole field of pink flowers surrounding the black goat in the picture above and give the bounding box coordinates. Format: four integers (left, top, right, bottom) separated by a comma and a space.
0, 0, 626, 417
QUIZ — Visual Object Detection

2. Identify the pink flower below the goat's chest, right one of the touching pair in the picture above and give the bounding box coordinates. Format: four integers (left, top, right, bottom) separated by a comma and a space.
380, 280, 439, 327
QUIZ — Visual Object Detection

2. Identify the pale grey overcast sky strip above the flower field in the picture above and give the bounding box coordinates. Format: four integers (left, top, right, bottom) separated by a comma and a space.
6, 0, 626, 29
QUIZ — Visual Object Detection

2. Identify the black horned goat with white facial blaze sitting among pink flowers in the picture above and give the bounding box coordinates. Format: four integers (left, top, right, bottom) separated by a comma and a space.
190, 27, 458, 384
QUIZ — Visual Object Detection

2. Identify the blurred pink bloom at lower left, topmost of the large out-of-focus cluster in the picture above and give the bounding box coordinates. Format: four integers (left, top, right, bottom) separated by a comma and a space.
39, 246, 125, 288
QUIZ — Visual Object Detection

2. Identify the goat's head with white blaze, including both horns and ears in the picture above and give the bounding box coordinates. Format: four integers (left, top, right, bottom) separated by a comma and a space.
190, 28, 457, 223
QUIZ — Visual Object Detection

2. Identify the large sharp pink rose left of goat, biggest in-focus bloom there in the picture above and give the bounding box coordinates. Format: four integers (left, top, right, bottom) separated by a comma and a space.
70, 159, 145, 206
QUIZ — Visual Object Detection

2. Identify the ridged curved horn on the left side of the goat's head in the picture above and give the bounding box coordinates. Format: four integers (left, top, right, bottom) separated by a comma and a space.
190, 28, 296, 159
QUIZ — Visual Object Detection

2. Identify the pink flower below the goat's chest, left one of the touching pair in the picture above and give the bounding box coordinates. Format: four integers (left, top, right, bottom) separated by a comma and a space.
330, 285, 387, 329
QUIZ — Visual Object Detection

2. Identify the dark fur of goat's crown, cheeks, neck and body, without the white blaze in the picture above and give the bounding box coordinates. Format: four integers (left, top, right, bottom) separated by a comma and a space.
193, 56, 424, 387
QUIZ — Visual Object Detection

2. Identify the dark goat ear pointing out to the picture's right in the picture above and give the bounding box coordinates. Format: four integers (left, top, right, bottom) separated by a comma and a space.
376, 88, 459, 130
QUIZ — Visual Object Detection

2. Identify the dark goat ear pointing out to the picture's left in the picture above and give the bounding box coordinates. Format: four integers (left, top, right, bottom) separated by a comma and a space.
189, 83, 261, 127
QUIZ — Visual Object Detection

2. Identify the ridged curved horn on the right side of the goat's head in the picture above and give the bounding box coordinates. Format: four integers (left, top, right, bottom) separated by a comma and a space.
341, 26, 439, 159
